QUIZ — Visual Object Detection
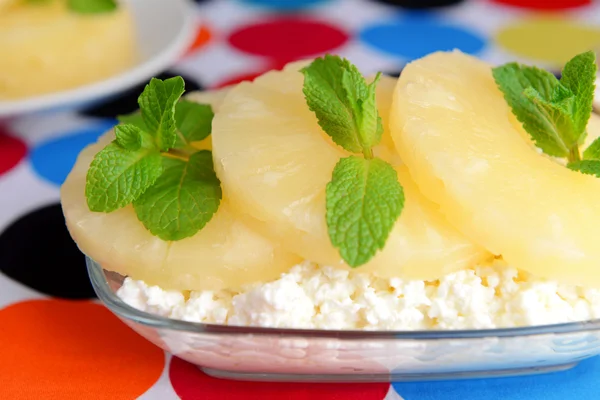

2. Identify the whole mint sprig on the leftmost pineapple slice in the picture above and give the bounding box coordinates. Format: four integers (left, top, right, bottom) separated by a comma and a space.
85, 77, 222, 241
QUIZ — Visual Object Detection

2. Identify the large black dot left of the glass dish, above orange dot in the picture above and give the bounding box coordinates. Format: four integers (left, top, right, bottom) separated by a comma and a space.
0, 204, 96, 299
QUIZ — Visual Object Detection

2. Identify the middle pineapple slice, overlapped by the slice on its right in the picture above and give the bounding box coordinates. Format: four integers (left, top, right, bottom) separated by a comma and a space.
213, 62, 490, 279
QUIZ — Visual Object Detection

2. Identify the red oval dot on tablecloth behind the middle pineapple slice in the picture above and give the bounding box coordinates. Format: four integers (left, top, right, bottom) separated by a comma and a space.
229, 17, 348, 62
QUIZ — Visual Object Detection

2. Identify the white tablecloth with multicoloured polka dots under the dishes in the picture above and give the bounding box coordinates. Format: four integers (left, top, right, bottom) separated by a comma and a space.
0, 0, 600, 400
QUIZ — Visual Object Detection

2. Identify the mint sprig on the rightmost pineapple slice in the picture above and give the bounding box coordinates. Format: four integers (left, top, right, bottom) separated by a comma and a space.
492, 51, 597, 166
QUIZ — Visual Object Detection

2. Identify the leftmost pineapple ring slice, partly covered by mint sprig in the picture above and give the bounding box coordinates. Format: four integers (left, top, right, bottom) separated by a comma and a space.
61, 93, 300, 290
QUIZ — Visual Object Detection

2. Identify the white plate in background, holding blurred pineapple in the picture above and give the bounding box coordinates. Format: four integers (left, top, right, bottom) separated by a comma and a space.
0, 0, 196, 117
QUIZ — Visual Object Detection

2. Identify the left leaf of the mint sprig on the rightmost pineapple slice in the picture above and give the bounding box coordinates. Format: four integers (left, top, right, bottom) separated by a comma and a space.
492, 63, 569, 157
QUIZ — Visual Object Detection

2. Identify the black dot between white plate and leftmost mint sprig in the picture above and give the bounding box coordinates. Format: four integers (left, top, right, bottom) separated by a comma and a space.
81, 71, 203, 118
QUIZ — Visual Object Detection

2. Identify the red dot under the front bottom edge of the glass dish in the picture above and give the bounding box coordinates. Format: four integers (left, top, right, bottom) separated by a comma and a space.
169, 357, 390, 400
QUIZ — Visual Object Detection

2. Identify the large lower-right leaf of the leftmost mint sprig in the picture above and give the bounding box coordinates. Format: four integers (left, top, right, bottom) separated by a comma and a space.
133, 150, 221, 241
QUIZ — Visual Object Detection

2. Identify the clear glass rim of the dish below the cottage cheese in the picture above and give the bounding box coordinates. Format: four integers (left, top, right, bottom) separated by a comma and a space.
85, 256, 600, 340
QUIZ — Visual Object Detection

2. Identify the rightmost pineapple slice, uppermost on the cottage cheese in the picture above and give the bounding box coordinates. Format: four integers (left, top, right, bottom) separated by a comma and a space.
390, 51, 600, 286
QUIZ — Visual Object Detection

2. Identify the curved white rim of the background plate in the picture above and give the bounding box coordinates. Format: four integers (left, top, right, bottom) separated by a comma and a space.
0, 0, 195, 117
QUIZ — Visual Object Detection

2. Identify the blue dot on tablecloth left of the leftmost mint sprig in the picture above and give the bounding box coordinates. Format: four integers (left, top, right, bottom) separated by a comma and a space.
30, 120, 116, 186
